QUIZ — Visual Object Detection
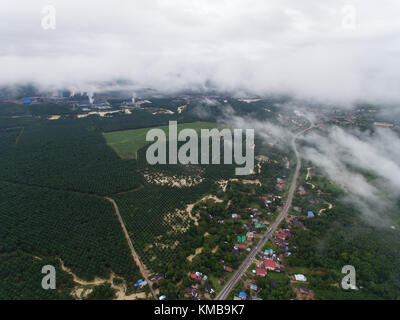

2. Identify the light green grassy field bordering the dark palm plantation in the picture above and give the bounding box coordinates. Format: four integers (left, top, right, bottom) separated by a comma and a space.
103, 122, 221, 159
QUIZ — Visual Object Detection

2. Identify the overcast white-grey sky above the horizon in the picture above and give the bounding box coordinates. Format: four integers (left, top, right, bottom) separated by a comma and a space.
0, 0, 400, 103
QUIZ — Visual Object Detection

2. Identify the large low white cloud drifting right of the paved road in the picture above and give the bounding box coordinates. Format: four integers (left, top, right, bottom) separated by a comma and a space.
301, 127, 400, 225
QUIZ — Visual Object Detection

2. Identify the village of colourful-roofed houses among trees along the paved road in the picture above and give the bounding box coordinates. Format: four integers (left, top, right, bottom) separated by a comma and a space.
175, 178, 315, 300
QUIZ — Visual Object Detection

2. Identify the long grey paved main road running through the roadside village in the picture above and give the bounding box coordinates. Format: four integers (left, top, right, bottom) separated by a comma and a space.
215, 122, 314, 300
